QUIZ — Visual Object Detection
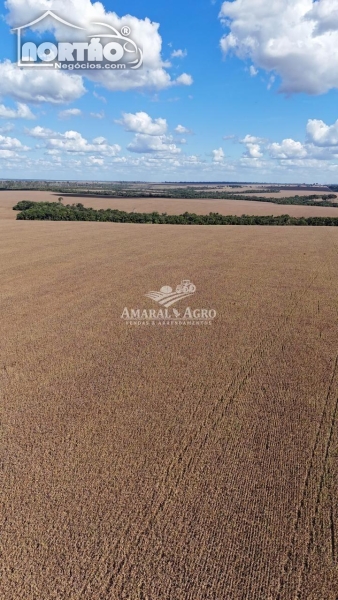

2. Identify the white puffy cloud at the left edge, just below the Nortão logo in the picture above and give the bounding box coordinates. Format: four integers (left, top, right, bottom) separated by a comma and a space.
0, 60, 85, 104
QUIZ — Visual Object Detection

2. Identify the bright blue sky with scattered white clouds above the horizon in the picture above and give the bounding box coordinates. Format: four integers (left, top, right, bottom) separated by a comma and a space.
0, 0, 338, 183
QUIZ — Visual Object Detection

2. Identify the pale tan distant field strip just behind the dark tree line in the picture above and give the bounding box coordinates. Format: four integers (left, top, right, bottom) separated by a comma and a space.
0, 192, 338, 219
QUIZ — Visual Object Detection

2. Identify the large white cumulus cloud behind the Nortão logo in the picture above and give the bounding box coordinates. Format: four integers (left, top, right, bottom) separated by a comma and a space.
6, 0, 192, 91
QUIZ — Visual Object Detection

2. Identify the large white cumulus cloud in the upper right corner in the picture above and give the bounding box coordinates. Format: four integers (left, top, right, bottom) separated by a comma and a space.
220, 0, 338, 94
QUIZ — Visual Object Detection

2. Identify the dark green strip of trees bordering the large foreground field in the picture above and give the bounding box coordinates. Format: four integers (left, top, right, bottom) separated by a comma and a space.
13, 200, 338, 227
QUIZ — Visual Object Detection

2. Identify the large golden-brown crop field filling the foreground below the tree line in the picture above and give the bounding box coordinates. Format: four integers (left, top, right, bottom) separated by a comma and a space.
0, 218, 338, 600
